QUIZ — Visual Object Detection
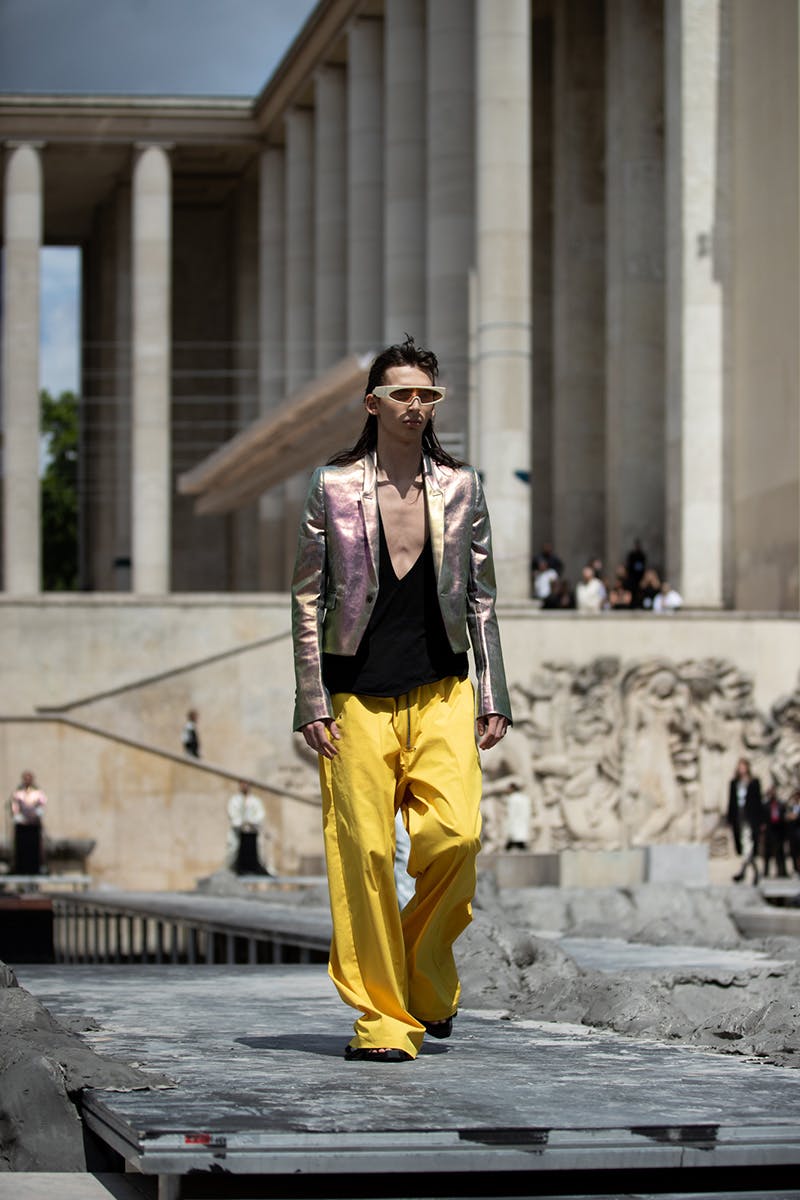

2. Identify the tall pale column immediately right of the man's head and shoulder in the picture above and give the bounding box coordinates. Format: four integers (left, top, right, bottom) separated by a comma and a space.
474, 0, 531, 600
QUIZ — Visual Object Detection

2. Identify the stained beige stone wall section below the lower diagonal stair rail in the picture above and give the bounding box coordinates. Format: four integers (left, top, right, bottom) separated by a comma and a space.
0, 719, 321, 890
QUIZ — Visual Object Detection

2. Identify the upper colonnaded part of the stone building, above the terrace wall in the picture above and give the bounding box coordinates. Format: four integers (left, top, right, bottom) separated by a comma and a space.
0, 0, 800, 611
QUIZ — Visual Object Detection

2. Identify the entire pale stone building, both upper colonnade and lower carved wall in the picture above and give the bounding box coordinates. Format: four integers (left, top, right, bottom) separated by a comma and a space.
0, 0, 800, 886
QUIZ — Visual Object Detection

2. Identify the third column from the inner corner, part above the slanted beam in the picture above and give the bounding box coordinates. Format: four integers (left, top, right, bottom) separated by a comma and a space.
314, 66, 348, 364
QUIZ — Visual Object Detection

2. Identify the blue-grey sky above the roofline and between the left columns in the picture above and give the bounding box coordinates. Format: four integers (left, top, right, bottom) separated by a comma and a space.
0, 0, 315, 395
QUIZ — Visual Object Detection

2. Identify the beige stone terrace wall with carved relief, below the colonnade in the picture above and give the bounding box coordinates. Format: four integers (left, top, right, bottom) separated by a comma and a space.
0, 595, 800, 887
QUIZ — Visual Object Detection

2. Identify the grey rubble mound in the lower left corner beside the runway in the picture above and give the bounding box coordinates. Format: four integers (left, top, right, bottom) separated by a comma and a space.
0, 964, 166, 1171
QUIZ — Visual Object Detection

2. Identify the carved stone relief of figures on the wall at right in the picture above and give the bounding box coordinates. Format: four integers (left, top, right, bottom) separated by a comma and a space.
483, 658, 800, 856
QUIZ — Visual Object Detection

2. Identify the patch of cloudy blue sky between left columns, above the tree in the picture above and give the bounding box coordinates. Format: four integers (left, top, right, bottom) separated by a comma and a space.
40, 246, 80, 396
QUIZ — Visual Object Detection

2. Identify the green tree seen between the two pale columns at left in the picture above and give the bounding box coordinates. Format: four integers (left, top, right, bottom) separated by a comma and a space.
41, 391, 78, 592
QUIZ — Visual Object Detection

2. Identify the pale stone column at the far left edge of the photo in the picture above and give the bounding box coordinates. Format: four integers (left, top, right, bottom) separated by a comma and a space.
2, 143, 42, 595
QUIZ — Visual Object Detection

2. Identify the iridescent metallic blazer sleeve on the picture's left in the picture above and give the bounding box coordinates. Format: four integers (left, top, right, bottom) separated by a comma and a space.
291, 467, 333, 730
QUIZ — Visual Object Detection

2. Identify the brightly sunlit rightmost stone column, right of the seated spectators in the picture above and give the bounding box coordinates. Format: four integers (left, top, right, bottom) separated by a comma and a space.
664, 0, 724, 608
